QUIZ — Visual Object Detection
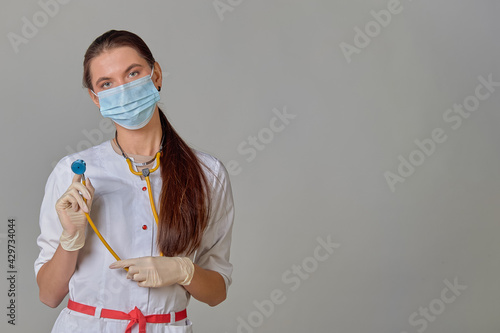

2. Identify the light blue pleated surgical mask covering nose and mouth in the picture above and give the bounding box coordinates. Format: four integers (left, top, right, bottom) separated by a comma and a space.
92, 67, 160, 130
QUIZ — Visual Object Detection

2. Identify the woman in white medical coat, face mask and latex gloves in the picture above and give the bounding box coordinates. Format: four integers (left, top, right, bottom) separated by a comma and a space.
35, 30, 234, 333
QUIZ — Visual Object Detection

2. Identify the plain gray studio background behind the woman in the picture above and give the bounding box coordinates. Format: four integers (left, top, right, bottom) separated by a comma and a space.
0, 0, 500, 333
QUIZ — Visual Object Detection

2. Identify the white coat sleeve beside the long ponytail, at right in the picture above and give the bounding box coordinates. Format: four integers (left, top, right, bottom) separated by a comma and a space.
195, 160, 234, 293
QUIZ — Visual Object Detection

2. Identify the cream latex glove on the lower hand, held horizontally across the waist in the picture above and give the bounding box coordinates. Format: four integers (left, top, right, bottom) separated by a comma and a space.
109, 257, 194, 288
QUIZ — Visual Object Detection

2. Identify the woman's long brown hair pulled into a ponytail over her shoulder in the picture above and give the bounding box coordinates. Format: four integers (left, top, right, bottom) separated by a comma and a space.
83, 30, 210, 257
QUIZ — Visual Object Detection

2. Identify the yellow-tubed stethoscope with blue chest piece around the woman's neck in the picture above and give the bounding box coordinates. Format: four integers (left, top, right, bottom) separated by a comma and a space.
71, 127, 165, 271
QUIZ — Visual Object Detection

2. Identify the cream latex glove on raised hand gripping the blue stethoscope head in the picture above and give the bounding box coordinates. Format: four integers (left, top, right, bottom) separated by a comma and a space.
56, 175, 94, 251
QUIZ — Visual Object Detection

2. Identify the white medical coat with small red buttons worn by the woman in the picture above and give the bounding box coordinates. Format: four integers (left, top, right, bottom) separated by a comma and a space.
34, 141, 234, 333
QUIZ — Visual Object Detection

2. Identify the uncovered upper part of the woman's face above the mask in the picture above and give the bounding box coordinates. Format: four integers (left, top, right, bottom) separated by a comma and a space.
89, 46, 161, 107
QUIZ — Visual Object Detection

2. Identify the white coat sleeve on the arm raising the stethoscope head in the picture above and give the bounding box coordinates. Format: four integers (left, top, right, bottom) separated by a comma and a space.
34, 158, 72, 275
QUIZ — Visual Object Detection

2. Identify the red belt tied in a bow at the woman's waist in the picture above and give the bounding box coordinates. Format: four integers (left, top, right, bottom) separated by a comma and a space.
68, 300, 187, 333
